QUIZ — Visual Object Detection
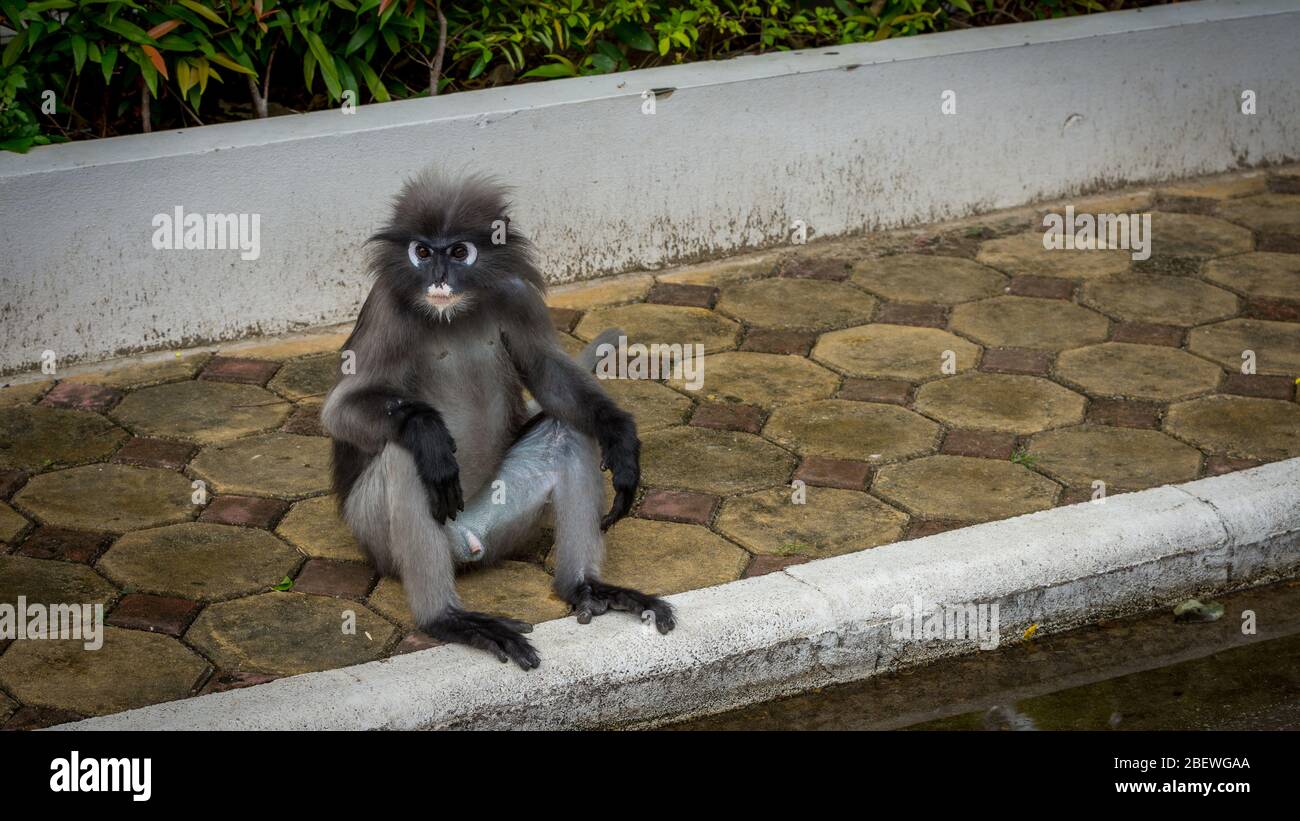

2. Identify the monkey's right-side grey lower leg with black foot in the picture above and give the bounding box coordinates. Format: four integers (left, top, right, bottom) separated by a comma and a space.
551, 425, 676, 633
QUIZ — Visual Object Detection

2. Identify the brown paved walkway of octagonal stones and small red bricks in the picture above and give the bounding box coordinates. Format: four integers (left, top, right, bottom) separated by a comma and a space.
0, 166, 1300, 727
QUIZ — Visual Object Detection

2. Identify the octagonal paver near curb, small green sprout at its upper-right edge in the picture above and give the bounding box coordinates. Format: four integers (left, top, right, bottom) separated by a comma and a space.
871, 456, 1061, 522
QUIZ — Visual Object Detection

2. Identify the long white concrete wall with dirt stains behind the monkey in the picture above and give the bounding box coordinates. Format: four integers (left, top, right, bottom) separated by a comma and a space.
0, 0, 1300, 372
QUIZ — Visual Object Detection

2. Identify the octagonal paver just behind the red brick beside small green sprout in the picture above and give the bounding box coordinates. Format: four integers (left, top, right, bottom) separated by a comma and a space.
915, 373, 1087, 434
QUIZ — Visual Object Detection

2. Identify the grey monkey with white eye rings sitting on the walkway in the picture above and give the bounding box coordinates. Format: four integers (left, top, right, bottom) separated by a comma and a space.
321, 169, 676, 670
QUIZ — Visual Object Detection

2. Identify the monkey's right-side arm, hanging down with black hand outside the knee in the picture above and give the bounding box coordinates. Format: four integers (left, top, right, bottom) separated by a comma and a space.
504, 310, 641, 530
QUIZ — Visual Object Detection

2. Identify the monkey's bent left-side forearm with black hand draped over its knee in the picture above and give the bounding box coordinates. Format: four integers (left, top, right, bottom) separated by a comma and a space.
321, 377, 465, 525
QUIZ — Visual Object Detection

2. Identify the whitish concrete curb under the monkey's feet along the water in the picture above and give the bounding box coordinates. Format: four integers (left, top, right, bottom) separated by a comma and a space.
59, 459, 1300, 730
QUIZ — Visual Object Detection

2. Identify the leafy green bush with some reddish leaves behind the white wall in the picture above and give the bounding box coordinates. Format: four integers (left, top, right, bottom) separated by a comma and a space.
0, 0, 1169, 151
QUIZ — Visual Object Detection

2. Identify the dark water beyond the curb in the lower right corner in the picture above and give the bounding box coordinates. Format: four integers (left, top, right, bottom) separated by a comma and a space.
672, 581, 1300, 730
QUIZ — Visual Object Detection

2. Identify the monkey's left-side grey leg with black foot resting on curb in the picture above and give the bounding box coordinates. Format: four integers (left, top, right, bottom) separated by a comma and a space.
343, 444, 538, 670
